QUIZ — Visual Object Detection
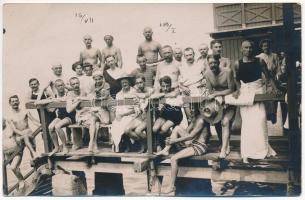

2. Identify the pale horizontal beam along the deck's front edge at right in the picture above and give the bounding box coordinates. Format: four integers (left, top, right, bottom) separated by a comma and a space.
157, 166, 288, 184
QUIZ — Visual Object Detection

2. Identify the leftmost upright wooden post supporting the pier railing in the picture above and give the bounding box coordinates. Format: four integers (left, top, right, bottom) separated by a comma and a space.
39, 107, 52, 153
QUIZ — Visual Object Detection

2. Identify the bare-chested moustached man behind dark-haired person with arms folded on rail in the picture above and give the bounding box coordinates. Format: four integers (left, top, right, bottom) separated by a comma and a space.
154, 45, 181, 91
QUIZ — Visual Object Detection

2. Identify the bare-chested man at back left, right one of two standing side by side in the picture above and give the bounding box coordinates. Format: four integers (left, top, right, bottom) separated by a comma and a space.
101, 35, 123, 70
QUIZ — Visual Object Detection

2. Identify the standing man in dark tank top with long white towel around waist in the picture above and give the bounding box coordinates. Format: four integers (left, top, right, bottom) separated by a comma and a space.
225, 40, 279, 163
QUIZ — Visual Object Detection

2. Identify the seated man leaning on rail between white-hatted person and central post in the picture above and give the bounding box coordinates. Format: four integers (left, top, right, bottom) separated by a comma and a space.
125, 75, 153, 153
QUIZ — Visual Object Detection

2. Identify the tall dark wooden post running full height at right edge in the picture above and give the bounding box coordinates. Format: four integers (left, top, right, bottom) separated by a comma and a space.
283, 3, 301, 195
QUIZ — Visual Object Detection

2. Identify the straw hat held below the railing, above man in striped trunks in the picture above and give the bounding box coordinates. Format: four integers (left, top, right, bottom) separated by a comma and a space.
200, 99, 223, 124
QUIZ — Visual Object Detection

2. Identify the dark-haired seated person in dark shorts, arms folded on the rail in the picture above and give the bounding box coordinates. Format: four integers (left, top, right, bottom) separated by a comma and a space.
151, 76, 183, 151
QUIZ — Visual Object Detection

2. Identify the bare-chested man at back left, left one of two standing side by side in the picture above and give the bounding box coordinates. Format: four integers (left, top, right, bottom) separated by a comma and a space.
79, 35, 103, 71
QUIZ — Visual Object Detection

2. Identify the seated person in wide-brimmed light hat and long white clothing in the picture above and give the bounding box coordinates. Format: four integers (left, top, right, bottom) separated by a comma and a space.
111, 74, 140, 152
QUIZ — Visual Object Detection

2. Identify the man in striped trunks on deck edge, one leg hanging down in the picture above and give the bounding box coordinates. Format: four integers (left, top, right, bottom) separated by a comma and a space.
157, 101, 208, 193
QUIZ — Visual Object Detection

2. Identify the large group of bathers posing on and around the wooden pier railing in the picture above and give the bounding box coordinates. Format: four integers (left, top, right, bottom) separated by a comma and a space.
4, 27, 283, 192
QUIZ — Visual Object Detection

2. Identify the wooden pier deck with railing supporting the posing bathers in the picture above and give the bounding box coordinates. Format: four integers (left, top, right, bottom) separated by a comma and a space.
4, 91, 297, 195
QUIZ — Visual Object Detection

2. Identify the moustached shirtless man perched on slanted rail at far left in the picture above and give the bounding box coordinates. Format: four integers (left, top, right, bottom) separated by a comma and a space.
7, 95, 40, 158
